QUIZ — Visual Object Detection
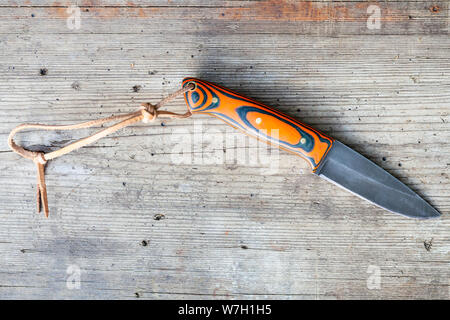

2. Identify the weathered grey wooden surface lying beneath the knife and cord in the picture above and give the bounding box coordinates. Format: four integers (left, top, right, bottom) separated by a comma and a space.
0, 0, 450, 299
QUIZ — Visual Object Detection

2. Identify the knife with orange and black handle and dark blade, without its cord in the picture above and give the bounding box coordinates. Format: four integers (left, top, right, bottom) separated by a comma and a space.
183, 78, 440, 219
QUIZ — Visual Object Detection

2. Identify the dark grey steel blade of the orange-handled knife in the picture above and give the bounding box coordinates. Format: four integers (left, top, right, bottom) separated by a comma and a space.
316, 141, 440, 219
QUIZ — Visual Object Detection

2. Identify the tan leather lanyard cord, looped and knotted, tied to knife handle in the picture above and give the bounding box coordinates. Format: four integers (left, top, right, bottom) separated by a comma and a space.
8, 84, 195, 217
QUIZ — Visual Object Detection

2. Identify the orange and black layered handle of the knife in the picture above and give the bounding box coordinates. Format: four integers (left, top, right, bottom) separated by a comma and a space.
183, 78, 334, 172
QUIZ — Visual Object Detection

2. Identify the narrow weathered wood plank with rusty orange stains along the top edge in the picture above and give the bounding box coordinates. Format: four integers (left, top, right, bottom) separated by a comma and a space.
0, 0, 449, 36
